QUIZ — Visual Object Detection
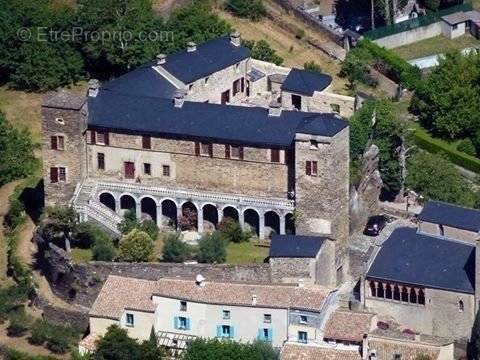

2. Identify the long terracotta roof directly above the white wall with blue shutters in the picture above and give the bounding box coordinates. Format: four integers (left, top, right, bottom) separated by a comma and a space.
154, 279, 330, 311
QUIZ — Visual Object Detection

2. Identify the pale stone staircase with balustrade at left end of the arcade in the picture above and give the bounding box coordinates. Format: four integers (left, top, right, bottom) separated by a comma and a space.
72, 179, 122, 237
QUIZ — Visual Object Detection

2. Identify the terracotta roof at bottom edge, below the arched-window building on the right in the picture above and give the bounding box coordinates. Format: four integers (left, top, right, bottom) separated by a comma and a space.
368, 338, 440, 360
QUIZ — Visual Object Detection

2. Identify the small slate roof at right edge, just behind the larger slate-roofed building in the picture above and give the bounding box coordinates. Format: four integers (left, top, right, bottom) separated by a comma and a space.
418, 201, 480, 232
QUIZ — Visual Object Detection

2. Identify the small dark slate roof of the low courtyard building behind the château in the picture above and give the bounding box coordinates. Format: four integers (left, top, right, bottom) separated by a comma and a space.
281, 69, 332, 96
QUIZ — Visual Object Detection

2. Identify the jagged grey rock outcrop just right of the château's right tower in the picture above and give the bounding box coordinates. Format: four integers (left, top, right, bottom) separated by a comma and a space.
350, 144, 383, 231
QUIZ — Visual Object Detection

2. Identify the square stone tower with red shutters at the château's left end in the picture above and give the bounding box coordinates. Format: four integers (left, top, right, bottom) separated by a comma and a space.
42, 91, 87, 206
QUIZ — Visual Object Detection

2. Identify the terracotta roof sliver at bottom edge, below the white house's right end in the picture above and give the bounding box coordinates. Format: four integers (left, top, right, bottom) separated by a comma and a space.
280, 343, 362, 360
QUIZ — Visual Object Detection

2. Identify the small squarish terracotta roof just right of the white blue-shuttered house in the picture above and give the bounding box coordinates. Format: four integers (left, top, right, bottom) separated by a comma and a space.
324, 309, 375, 342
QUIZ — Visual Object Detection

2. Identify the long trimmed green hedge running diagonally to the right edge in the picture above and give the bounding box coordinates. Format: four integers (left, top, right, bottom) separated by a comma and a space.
414, 129, 480, 173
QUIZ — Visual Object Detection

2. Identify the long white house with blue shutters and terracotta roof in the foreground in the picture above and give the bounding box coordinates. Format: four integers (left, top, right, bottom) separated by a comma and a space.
80, 275, 337, 351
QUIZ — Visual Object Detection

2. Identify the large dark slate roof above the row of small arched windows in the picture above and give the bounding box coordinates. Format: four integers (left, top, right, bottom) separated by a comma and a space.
367, 228, 475, 294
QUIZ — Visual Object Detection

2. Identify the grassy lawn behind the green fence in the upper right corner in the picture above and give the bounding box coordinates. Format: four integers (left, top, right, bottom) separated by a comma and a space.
392, 34, 480, 60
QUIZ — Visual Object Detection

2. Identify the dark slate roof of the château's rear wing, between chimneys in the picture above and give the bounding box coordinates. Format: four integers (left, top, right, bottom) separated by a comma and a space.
160, 36, 250, 84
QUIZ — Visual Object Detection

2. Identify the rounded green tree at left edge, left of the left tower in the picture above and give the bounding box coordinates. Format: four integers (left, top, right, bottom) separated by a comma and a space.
0, 112, 38, 186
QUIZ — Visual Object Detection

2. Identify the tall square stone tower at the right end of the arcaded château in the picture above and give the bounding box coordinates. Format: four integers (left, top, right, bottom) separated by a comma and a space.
295, 127, 350, 285
